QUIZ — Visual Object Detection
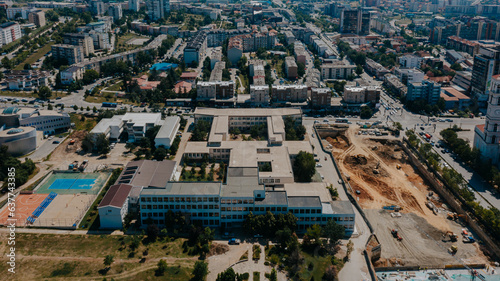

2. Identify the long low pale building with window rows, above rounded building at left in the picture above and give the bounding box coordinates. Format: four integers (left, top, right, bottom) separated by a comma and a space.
0, 107, 71, 135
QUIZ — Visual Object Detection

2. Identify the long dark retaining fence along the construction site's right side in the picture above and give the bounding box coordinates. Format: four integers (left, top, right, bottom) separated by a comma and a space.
399, 138, 500, 258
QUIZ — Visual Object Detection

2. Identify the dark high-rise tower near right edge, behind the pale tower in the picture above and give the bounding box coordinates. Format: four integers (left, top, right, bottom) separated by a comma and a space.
471, 46, 500, 103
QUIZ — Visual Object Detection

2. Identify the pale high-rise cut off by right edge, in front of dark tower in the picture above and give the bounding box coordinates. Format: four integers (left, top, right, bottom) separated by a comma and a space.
474, 75, 500, 165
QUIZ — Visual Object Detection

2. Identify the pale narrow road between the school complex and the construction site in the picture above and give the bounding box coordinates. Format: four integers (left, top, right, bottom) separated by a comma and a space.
303, 122, 370, 281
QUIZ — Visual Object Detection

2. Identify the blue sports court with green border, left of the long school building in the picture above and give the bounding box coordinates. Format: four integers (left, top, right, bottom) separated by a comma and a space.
35, 173, 109, 195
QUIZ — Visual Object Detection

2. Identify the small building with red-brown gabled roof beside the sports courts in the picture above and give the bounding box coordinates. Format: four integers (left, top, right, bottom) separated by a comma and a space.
97, 184, 132, 229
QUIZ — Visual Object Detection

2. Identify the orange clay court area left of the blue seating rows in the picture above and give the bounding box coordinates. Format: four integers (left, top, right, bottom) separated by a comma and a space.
0, 194, 51, 226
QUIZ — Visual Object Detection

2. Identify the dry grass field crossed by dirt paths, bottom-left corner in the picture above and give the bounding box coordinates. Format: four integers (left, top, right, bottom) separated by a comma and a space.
0, 233, 196, 281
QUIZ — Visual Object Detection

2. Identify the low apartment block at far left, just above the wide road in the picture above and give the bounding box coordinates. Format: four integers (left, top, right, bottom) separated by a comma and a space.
5, 69, 50, 91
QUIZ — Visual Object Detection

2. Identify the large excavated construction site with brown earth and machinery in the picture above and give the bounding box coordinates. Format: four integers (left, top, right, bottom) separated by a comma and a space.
318, 125, 488, 270
